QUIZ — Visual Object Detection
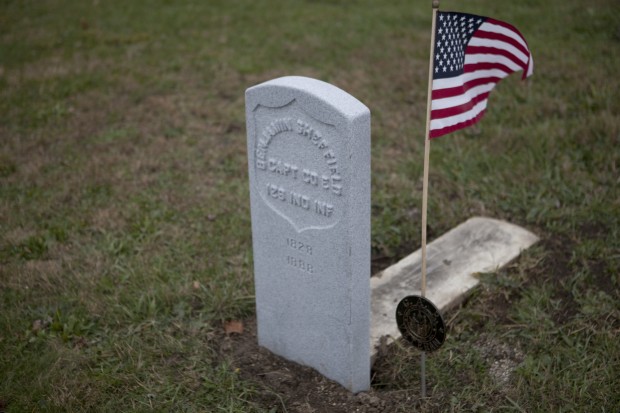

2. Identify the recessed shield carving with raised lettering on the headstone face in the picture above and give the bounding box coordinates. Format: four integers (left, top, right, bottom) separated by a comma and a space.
252, 100, 346, 232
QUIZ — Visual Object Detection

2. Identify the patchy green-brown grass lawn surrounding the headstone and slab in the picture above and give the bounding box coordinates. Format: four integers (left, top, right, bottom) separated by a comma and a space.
0, 0, 620, 412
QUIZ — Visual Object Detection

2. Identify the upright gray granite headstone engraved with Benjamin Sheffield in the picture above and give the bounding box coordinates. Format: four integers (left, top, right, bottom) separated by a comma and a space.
246, 76, 370, 392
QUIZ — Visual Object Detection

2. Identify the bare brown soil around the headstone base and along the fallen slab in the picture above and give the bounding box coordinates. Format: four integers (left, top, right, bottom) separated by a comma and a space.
212, 232, 604, 413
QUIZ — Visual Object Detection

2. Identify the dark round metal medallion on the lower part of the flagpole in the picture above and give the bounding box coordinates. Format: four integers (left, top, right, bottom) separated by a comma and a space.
396, 295, 446, 352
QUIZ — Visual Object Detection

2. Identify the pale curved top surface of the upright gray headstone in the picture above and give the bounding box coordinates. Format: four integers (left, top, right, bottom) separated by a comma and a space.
245, 76, 370, 124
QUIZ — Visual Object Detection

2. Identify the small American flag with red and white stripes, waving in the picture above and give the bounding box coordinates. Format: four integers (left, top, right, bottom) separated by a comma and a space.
429, 12, 534, 138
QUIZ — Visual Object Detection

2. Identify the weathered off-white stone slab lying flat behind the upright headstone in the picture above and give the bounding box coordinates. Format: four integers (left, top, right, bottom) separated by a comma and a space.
370, 217, 538, 357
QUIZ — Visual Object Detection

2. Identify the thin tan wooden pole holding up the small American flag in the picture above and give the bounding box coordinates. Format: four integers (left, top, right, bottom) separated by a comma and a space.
420, 0, 439, 398
